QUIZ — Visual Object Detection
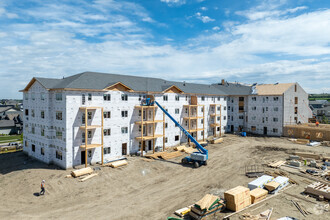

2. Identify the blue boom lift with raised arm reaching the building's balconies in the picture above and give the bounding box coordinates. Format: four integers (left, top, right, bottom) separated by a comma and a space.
145, 98, 209, 168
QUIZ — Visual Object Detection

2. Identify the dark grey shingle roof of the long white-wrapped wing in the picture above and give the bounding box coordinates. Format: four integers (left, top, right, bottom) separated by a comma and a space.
32, 72, 251, 95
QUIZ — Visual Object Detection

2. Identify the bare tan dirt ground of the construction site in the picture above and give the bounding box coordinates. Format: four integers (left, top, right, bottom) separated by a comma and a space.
0, 135, 330, 219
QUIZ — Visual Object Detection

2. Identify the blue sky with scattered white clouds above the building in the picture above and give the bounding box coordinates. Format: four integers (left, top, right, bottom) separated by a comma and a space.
0, 0, 330, 98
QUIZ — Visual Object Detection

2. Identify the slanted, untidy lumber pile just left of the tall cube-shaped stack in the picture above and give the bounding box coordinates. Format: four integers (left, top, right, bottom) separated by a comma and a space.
189, 194, 225, 219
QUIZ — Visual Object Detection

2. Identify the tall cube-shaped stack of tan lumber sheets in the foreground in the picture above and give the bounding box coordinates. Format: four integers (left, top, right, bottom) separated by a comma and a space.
225, 186, 251, 212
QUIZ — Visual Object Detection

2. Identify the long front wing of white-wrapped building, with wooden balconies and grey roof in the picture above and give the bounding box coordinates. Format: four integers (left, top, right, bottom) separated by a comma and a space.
23, 72, 227, 168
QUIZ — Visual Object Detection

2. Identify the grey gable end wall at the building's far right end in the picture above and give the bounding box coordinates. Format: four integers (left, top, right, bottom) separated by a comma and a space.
283, 83, 313, 125
